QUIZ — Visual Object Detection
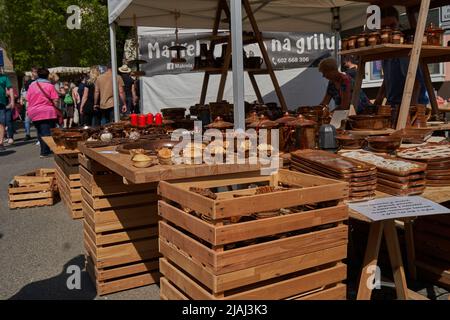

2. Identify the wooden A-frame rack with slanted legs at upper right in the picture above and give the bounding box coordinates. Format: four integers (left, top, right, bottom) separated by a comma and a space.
340, 0, 450, 130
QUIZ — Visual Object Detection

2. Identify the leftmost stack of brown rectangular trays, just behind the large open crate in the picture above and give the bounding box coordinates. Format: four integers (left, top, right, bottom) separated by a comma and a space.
291, 150, 377, 201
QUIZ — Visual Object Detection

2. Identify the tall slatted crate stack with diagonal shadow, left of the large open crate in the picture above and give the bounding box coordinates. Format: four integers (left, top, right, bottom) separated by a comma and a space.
80, 155, 160, 295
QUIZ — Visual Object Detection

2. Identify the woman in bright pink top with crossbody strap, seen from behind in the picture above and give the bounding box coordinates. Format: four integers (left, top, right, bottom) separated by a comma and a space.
27, 68, 59, 158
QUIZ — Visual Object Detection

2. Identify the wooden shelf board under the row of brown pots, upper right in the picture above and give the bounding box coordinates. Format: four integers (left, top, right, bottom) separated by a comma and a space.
340, 44, 450, 63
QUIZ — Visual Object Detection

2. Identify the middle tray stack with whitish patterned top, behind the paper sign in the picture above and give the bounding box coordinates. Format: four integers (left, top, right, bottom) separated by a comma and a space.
341, 151, 427, 196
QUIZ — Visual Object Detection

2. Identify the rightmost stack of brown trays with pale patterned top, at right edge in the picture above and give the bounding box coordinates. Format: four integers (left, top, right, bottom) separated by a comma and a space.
397, 144, 450, 187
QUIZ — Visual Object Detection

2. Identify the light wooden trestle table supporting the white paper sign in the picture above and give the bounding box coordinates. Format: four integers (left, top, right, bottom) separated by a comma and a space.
350, 187, 450, 300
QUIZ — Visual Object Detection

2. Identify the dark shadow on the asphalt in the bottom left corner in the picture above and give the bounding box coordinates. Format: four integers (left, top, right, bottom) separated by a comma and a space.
9, 255, 97, 300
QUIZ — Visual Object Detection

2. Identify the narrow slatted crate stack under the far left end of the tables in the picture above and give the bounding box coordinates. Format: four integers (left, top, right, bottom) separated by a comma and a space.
55, 153, 83, 219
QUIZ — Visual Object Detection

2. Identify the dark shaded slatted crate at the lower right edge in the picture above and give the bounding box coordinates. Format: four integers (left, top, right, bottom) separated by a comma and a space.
414, 214, 450, 289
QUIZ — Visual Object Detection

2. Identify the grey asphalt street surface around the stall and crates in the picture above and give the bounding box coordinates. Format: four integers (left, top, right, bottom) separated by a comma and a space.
0, 127, 448, 300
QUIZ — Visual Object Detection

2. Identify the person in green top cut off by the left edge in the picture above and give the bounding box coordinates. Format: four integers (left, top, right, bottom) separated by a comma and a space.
0, 69, 15, 151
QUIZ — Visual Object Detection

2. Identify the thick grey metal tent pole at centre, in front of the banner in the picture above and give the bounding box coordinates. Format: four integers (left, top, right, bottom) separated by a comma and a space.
230, 0, 245, 130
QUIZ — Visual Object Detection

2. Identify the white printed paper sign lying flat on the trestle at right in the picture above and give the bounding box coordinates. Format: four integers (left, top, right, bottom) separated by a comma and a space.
349, 197, 450, 221
